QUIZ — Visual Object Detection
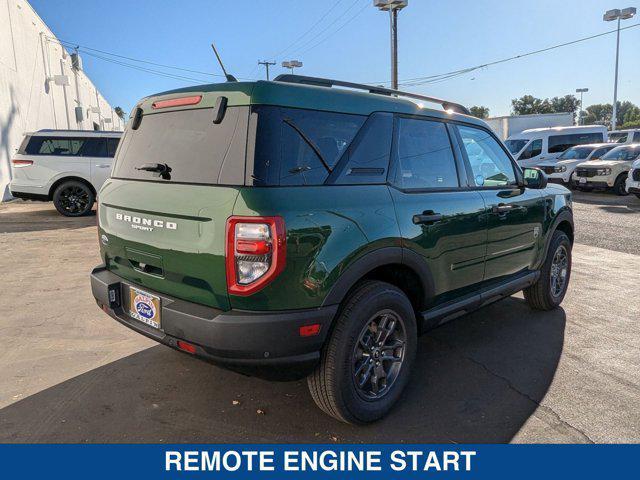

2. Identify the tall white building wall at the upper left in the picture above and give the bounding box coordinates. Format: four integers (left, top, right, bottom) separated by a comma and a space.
0, 0, 124, 200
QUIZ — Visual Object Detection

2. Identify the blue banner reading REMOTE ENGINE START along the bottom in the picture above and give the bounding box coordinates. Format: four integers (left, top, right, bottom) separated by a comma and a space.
0, 444, 640, 480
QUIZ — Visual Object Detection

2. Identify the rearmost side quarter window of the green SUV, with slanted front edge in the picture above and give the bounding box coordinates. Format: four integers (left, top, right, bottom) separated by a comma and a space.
280, 109, 365, 186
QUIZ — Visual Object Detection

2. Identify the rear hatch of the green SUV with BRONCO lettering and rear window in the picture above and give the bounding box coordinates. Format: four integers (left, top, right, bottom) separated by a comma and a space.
98, 84, 249, 310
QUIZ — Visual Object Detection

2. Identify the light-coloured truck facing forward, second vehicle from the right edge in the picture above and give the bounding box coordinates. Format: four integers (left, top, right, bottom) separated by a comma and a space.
573, 143, 640, 195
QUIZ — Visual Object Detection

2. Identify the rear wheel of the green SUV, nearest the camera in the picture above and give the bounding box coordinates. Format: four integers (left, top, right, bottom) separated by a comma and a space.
307, 281, 417, 423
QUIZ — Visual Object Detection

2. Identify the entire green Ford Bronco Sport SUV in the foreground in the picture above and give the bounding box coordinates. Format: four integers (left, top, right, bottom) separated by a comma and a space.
91, 75, 573, 423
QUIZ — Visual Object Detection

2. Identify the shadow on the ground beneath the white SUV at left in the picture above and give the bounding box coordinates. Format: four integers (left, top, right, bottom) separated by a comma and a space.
0, 202, 96, 233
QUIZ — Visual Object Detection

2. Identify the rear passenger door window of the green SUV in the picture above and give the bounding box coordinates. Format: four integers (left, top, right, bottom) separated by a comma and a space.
393, 117, 459, 189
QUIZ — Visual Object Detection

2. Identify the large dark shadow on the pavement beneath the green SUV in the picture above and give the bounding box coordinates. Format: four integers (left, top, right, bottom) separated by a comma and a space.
0, 298, 565, 443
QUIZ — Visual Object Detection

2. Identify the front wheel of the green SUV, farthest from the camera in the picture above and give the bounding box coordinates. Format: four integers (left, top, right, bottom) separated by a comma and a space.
524, 230, 571, 310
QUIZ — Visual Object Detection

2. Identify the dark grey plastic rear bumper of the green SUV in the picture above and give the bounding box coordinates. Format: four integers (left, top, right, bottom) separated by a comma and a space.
91, 266, 338, 378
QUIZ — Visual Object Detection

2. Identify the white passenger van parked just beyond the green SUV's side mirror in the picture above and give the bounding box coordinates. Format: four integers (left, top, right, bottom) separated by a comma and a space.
504, 125, 607, 168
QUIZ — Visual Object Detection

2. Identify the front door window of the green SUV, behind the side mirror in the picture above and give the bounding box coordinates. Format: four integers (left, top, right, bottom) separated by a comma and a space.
458, 126, 516, 187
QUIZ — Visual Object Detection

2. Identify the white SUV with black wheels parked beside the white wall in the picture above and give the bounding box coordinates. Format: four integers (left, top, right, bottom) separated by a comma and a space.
9, 130, 122, 217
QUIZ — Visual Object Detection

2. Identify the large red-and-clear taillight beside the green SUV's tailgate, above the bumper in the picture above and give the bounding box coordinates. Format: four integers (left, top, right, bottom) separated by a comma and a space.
226, 217, 287, 295
